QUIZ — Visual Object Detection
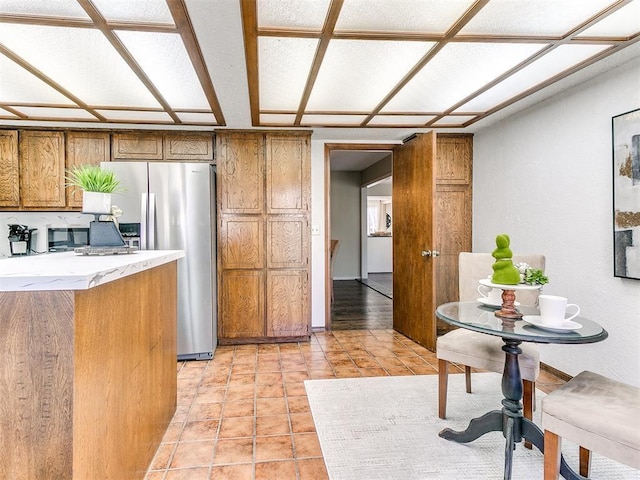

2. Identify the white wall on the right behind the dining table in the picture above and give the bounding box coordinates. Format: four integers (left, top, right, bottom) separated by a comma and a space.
473, 54, 640, 385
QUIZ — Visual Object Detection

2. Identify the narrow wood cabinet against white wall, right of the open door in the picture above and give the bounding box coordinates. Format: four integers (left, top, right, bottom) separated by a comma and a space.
434, 134, 473, 333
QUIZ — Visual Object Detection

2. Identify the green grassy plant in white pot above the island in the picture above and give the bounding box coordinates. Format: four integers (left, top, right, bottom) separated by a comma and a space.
65, 165, 123, 214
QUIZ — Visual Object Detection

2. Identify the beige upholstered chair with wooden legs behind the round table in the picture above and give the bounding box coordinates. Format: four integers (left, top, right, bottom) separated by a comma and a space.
436, 252, 545, 448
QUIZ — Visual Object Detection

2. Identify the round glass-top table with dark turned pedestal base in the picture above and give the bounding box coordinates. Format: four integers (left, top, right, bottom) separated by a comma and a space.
436, 302, 608, 480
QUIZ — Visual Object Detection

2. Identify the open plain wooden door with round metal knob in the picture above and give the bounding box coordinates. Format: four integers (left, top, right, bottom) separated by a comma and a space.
393, 131, 438, 350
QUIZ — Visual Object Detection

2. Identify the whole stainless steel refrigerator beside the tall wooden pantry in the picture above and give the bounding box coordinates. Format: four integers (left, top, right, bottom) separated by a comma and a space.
101, 162, 217, 360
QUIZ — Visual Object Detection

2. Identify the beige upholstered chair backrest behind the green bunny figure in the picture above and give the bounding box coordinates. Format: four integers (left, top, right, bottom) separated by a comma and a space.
458, 252, 545, 305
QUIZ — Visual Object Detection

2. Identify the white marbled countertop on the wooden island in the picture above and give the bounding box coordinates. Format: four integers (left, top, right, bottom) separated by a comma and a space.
0, 250, 184, 292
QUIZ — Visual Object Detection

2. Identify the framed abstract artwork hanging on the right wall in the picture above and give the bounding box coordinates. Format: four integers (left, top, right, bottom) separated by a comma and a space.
611, 108, 640, 280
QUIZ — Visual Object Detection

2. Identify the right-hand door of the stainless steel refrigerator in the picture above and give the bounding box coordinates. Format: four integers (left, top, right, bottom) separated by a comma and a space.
149, 163, 217, 359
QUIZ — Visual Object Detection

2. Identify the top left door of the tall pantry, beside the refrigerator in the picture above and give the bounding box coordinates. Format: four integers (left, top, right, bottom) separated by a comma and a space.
216, 134, 264, 214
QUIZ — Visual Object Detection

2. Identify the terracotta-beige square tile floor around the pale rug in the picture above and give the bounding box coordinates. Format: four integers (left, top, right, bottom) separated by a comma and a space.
146, 330, 564, 480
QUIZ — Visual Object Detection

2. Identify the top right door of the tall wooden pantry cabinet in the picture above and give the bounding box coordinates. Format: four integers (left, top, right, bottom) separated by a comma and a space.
266, 134, 311, 213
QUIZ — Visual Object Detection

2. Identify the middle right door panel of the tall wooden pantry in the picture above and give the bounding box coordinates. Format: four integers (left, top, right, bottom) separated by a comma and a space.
267, 215, 309, 268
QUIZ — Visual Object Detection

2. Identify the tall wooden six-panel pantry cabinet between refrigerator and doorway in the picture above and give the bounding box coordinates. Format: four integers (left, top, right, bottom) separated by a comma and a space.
216, 132, 311, 344
